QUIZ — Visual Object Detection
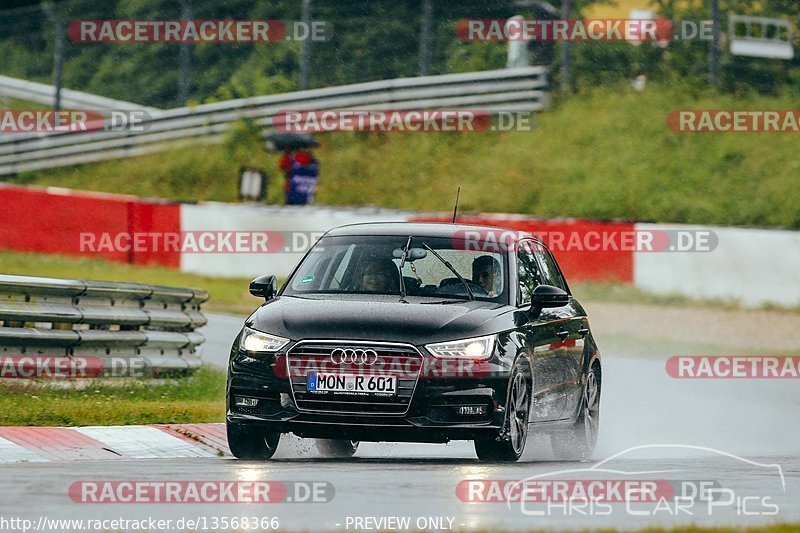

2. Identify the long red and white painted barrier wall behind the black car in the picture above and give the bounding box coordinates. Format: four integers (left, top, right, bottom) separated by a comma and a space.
0, 185, 800, 306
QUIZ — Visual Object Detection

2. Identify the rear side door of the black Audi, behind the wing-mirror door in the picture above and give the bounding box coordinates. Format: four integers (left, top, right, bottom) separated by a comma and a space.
535, 246, 589, 418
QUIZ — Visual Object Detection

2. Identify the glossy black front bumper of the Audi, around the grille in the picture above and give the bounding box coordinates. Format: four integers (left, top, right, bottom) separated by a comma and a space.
227, 345, 510, 442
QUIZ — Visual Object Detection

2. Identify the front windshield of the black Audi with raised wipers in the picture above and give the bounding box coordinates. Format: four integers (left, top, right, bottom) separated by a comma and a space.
283, 235, 508, 302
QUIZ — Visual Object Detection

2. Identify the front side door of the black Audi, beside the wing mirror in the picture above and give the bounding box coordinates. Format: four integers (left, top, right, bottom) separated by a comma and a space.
517, 241, 566, 422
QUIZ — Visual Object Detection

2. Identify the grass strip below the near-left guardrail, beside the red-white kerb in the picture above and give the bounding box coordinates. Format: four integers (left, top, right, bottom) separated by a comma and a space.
0, 367, 225, 426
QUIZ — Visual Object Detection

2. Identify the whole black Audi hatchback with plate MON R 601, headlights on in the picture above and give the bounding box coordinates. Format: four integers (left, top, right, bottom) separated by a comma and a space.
226, 223, 602, 461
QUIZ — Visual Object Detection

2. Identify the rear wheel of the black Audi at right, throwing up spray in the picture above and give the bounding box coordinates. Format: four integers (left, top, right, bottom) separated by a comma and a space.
550, 365, 601, 461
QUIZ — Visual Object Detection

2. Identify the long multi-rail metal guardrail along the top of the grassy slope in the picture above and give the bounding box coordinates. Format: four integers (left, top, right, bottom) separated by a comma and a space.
0, 67, 549, 176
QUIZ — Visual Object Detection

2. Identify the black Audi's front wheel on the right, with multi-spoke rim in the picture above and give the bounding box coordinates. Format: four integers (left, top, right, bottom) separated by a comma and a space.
475, 365, 531, 462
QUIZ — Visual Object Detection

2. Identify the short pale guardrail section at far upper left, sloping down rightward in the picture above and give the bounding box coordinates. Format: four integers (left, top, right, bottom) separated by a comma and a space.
0, 76, 161, 114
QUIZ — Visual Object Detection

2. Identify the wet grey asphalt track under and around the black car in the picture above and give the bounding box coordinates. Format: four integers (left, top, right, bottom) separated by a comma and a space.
0, 315, 800, 531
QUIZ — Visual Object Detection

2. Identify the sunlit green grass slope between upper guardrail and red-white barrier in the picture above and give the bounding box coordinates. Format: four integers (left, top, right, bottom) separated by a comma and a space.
9, 84, 800, 229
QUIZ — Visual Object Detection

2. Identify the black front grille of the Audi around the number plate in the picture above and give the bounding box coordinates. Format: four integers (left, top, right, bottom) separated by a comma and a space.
287, 341, 423, 416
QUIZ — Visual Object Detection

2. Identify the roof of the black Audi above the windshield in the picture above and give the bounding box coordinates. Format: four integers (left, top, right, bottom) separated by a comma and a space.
325, 222, 539, 242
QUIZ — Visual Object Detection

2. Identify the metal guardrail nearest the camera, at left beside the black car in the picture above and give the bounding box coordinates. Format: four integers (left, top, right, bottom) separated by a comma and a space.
0, 275, 209, 377
